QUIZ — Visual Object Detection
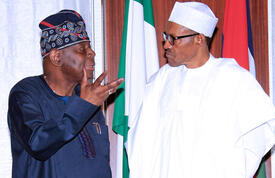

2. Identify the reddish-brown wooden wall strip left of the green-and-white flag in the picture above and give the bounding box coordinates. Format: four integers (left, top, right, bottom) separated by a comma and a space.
103, 0, 124, 178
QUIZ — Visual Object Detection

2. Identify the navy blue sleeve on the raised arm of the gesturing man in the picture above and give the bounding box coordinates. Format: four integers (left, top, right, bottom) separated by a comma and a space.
8, 91, 99, 161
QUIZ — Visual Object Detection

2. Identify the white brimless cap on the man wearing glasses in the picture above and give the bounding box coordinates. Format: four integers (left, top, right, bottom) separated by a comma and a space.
168, 2, 218, 37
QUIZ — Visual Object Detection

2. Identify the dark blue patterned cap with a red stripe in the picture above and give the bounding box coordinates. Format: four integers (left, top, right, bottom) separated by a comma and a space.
39, 10, 90, 58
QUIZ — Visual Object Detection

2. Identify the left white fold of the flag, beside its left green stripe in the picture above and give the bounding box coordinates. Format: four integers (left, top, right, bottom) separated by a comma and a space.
125, 1, 146, 120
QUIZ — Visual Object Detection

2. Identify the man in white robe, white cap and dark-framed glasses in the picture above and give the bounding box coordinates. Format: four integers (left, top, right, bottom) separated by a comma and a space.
127, 2, 275, 178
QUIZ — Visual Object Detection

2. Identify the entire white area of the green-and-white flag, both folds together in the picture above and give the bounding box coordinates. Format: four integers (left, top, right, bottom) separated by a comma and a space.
125, 1, 159, 127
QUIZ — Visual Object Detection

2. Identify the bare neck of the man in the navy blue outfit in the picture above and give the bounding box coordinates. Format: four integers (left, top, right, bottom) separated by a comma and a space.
43, 74, 77, 96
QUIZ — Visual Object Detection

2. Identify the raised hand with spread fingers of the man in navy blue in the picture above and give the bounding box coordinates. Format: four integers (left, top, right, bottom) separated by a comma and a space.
80, 69, 124, 106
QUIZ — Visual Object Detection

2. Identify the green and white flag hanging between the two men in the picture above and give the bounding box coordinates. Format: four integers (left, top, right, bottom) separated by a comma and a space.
113, 0, 159, 178
